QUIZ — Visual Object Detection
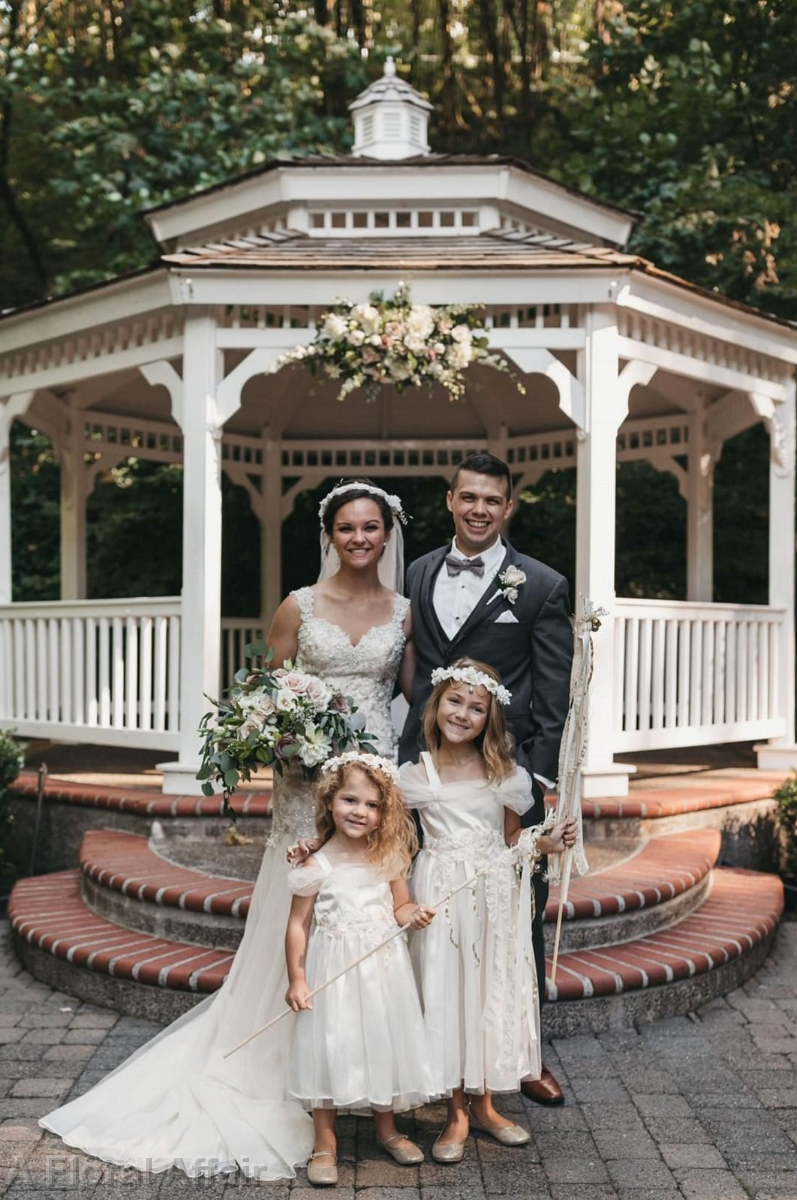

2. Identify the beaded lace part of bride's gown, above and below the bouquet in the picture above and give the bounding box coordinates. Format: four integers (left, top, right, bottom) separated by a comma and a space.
271, 588, 409, 842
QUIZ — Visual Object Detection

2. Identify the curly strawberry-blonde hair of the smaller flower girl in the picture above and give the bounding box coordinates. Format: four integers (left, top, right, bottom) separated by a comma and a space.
314, 762, 418, 878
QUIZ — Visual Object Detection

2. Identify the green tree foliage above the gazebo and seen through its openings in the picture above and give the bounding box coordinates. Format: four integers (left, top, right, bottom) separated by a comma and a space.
0, 0, 797, 600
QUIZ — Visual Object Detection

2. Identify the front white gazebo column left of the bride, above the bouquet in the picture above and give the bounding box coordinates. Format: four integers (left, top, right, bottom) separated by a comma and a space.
162, 310, 223, 796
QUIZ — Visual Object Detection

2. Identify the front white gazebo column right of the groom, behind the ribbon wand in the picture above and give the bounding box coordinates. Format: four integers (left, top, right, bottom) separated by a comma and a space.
574, 306, 634, 797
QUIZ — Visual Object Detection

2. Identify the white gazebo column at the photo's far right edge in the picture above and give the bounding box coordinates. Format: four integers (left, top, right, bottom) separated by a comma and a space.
755, 379, 797, 770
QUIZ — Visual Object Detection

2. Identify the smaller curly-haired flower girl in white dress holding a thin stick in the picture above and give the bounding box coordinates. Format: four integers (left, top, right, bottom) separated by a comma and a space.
286, 751, 433, 1184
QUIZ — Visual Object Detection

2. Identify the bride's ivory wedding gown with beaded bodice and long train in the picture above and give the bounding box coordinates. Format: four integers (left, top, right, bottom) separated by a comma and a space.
40, 588, 409, 1180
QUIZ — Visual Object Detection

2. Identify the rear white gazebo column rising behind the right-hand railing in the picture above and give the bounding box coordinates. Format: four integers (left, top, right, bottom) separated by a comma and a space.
687, 404, 717, 602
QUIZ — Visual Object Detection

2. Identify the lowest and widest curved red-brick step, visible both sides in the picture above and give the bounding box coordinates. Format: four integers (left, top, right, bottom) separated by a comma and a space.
8, 869, 783, 1036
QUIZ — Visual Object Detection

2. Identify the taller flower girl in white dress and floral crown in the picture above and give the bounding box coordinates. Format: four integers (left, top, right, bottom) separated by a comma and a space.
401, 659, 575, 1163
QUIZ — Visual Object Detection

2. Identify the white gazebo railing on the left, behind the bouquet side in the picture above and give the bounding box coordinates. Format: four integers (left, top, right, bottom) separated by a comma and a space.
0, 596, 180, 750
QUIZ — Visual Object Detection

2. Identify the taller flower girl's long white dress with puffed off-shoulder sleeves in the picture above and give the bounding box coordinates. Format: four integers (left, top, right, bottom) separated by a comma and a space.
401, 752, 541, 1096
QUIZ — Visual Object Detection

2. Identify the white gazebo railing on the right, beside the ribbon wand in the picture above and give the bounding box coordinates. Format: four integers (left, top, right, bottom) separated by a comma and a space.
613, 599, 786, 752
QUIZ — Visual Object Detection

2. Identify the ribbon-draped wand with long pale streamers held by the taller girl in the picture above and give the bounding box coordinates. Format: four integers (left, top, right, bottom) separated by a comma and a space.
549, 596, 609, 983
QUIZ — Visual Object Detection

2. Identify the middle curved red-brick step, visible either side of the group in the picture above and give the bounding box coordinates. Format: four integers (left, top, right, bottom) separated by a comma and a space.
79, 829, 720, 950
